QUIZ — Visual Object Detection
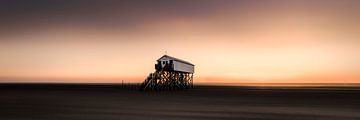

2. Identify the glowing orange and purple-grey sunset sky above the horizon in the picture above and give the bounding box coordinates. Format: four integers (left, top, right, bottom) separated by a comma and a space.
0, 0, 360, 83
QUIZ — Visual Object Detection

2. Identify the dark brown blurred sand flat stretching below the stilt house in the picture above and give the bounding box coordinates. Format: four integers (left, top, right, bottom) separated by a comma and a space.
0, 85, 360, 120
